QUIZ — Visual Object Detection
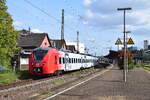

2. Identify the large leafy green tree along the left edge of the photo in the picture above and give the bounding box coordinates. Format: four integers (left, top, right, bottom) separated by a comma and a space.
0, 0, 18, 67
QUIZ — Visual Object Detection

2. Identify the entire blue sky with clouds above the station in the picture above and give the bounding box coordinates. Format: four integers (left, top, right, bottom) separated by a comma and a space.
7, 0, 150, 55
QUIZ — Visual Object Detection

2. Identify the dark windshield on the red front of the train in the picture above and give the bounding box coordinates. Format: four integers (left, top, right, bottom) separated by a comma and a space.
33, 50, 48, 62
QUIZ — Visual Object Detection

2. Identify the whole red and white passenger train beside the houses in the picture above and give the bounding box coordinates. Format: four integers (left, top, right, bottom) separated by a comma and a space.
29, 47, 98, 75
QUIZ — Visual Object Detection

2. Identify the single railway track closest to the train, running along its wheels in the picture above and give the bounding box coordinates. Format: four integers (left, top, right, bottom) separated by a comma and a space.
0, 66, 104, 94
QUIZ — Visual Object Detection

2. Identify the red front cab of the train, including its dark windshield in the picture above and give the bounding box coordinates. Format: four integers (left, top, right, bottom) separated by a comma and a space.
29, 49, 60, 75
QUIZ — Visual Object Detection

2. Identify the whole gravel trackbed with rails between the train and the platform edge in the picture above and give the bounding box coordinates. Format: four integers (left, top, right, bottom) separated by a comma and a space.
0, 65, 110, 100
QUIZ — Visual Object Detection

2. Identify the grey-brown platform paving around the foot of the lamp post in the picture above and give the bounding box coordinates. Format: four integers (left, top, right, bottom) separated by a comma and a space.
51, 67, 150, 100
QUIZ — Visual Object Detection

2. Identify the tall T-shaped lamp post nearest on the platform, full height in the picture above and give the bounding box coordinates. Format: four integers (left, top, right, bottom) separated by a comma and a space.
117, 8, 131, 82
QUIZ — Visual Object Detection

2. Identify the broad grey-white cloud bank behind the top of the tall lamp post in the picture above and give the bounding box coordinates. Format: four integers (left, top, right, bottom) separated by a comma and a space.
82, 0, 150, 31
